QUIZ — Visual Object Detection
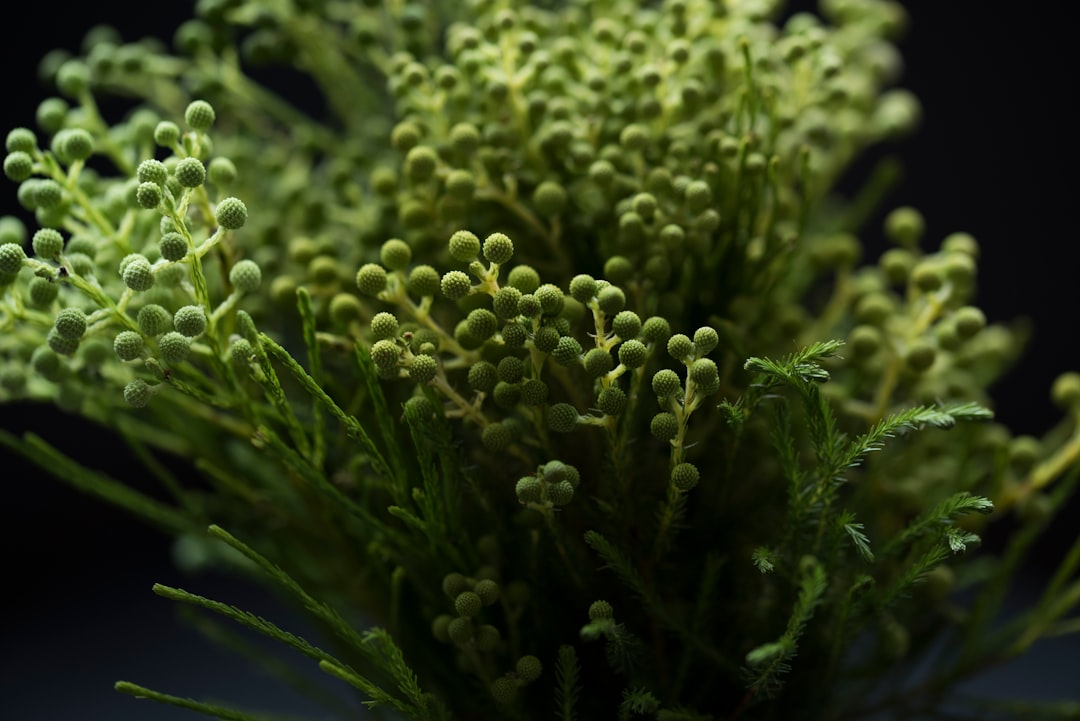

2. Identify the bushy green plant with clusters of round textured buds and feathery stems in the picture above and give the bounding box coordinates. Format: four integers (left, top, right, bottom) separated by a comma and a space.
0, 0, 1080, 720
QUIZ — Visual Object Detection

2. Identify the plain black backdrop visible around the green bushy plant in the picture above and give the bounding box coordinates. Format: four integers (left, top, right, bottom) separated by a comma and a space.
0, 0, 1080, 721
